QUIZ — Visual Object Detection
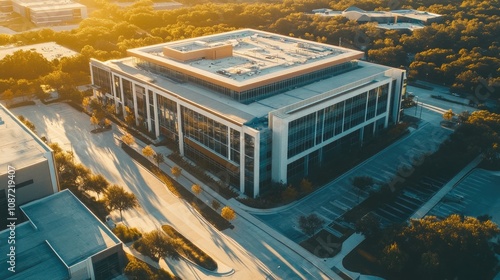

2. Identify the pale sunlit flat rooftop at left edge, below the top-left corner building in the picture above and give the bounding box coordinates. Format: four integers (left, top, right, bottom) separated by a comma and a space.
0, 42, 78, 61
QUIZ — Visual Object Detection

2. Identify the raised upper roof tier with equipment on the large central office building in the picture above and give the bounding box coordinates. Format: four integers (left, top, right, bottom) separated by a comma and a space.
129, 29, 363, 86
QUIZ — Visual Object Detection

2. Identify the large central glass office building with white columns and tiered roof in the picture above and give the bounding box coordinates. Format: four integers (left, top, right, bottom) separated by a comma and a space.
90, 29, 406, 197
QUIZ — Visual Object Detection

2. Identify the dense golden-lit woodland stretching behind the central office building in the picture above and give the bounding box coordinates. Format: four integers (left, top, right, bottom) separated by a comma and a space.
0, 0, 500, 100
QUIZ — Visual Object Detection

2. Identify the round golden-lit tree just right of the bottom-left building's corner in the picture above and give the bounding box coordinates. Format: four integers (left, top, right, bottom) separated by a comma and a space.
140, 230, 179, 259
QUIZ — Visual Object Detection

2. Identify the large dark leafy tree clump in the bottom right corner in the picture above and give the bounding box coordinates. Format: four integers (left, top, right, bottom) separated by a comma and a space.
381, 214, 500, 279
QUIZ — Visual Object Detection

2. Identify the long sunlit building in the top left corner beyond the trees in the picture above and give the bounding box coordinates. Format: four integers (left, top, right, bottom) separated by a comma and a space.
10, 0, 87, 25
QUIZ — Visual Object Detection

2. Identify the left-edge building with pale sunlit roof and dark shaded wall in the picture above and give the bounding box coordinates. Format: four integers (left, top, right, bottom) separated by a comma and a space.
0, 104, 59, 229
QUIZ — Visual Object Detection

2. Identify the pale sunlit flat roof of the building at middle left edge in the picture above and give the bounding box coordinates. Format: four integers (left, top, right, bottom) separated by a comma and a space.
0, 104, 51, 174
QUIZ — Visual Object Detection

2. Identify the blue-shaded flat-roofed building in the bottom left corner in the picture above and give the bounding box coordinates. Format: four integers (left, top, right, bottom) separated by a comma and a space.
0, 190, 126, 280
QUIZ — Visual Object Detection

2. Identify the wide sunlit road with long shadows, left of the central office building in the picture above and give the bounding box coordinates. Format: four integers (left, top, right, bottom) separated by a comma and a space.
8, 103, 328, 280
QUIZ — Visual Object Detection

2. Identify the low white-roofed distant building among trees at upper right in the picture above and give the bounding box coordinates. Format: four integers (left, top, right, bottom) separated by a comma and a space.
313, 6, 442, 31
